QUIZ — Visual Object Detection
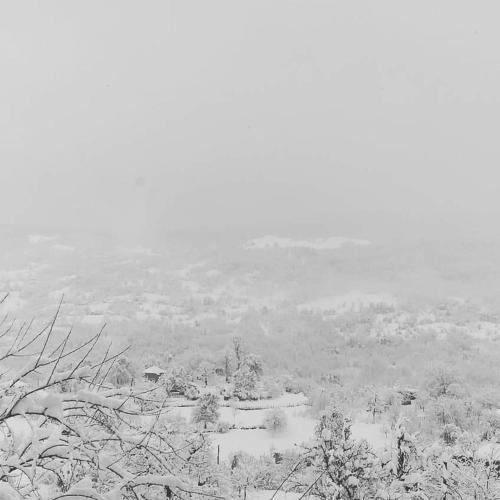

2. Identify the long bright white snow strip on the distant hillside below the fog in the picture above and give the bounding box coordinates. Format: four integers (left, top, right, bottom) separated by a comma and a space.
244, 235, 372, 250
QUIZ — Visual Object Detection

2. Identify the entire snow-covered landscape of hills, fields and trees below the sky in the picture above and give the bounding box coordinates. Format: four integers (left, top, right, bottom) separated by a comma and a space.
0, 232, 500, 500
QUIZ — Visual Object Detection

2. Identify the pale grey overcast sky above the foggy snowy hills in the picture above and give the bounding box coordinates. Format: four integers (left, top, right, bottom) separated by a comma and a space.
0, 0, 500, 236
